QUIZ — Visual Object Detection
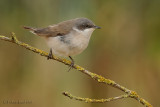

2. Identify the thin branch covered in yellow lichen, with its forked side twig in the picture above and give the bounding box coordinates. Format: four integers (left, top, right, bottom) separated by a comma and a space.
0, 33, 152, 107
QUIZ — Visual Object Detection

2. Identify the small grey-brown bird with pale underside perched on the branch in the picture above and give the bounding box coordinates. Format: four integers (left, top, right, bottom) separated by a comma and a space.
23, 17, 101, 71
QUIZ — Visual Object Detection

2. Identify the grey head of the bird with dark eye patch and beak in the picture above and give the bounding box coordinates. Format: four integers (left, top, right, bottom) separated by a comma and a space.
74, 18, 100, 31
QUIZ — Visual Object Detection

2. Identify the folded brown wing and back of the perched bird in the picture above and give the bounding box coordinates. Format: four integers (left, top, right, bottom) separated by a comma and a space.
33, 21, 73, 37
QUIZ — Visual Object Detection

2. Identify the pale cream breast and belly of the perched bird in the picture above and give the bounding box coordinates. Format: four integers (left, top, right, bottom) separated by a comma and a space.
47, 30, 93, 56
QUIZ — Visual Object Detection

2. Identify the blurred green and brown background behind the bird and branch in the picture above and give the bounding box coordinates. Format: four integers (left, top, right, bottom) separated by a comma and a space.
0, 0, 160, 107
